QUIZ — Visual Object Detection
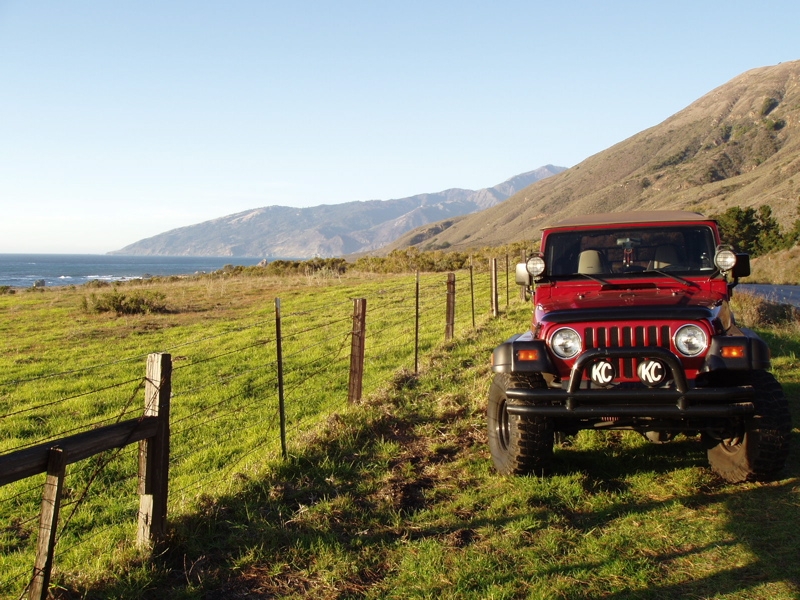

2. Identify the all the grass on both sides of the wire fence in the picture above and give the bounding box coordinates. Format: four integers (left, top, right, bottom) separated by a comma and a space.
0, 278, 800, 600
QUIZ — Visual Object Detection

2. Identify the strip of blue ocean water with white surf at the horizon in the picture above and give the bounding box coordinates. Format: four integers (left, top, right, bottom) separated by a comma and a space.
0, 254, 271, 287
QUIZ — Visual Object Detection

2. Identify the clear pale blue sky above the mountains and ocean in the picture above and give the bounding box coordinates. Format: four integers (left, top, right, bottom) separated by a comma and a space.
0, 0, 800, 253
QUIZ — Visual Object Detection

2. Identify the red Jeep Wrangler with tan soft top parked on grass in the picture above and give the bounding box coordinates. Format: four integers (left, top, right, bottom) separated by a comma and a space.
488, 211, 791, 482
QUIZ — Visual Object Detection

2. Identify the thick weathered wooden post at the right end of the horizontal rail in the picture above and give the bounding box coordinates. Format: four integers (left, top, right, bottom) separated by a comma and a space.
136, 353, 172, 547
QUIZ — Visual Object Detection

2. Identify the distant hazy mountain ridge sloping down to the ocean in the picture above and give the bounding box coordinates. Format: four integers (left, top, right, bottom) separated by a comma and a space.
111, 165, 564, 258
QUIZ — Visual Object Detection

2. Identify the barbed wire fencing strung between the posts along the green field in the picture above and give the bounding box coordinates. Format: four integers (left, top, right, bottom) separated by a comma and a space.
0, 260, 520, 598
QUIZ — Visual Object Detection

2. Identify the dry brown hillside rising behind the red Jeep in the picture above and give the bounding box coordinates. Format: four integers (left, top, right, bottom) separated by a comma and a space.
382, 61, 800, 252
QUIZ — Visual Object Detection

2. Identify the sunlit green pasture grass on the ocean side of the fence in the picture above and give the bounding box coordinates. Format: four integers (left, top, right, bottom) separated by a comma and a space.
0, 274, 496, 595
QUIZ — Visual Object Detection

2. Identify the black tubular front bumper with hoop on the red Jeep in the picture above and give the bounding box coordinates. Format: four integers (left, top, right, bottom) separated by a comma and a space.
506, 348, 755, 419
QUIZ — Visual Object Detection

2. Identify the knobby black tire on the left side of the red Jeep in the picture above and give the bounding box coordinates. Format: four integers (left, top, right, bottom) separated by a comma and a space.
487, 373, 553, 475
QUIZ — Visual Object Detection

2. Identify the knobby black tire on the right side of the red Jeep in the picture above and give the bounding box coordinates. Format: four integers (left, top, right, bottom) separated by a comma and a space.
708, 371, 792, 483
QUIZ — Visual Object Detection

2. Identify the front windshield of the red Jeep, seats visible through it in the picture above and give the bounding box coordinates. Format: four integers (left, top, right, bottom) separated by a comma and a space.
544, 225, 716, 279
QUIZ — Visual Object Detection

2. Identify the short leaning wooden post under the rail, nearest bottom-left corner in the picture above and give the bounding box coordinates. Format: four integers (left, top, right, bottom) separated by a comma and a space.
28, 446, 67, 600
